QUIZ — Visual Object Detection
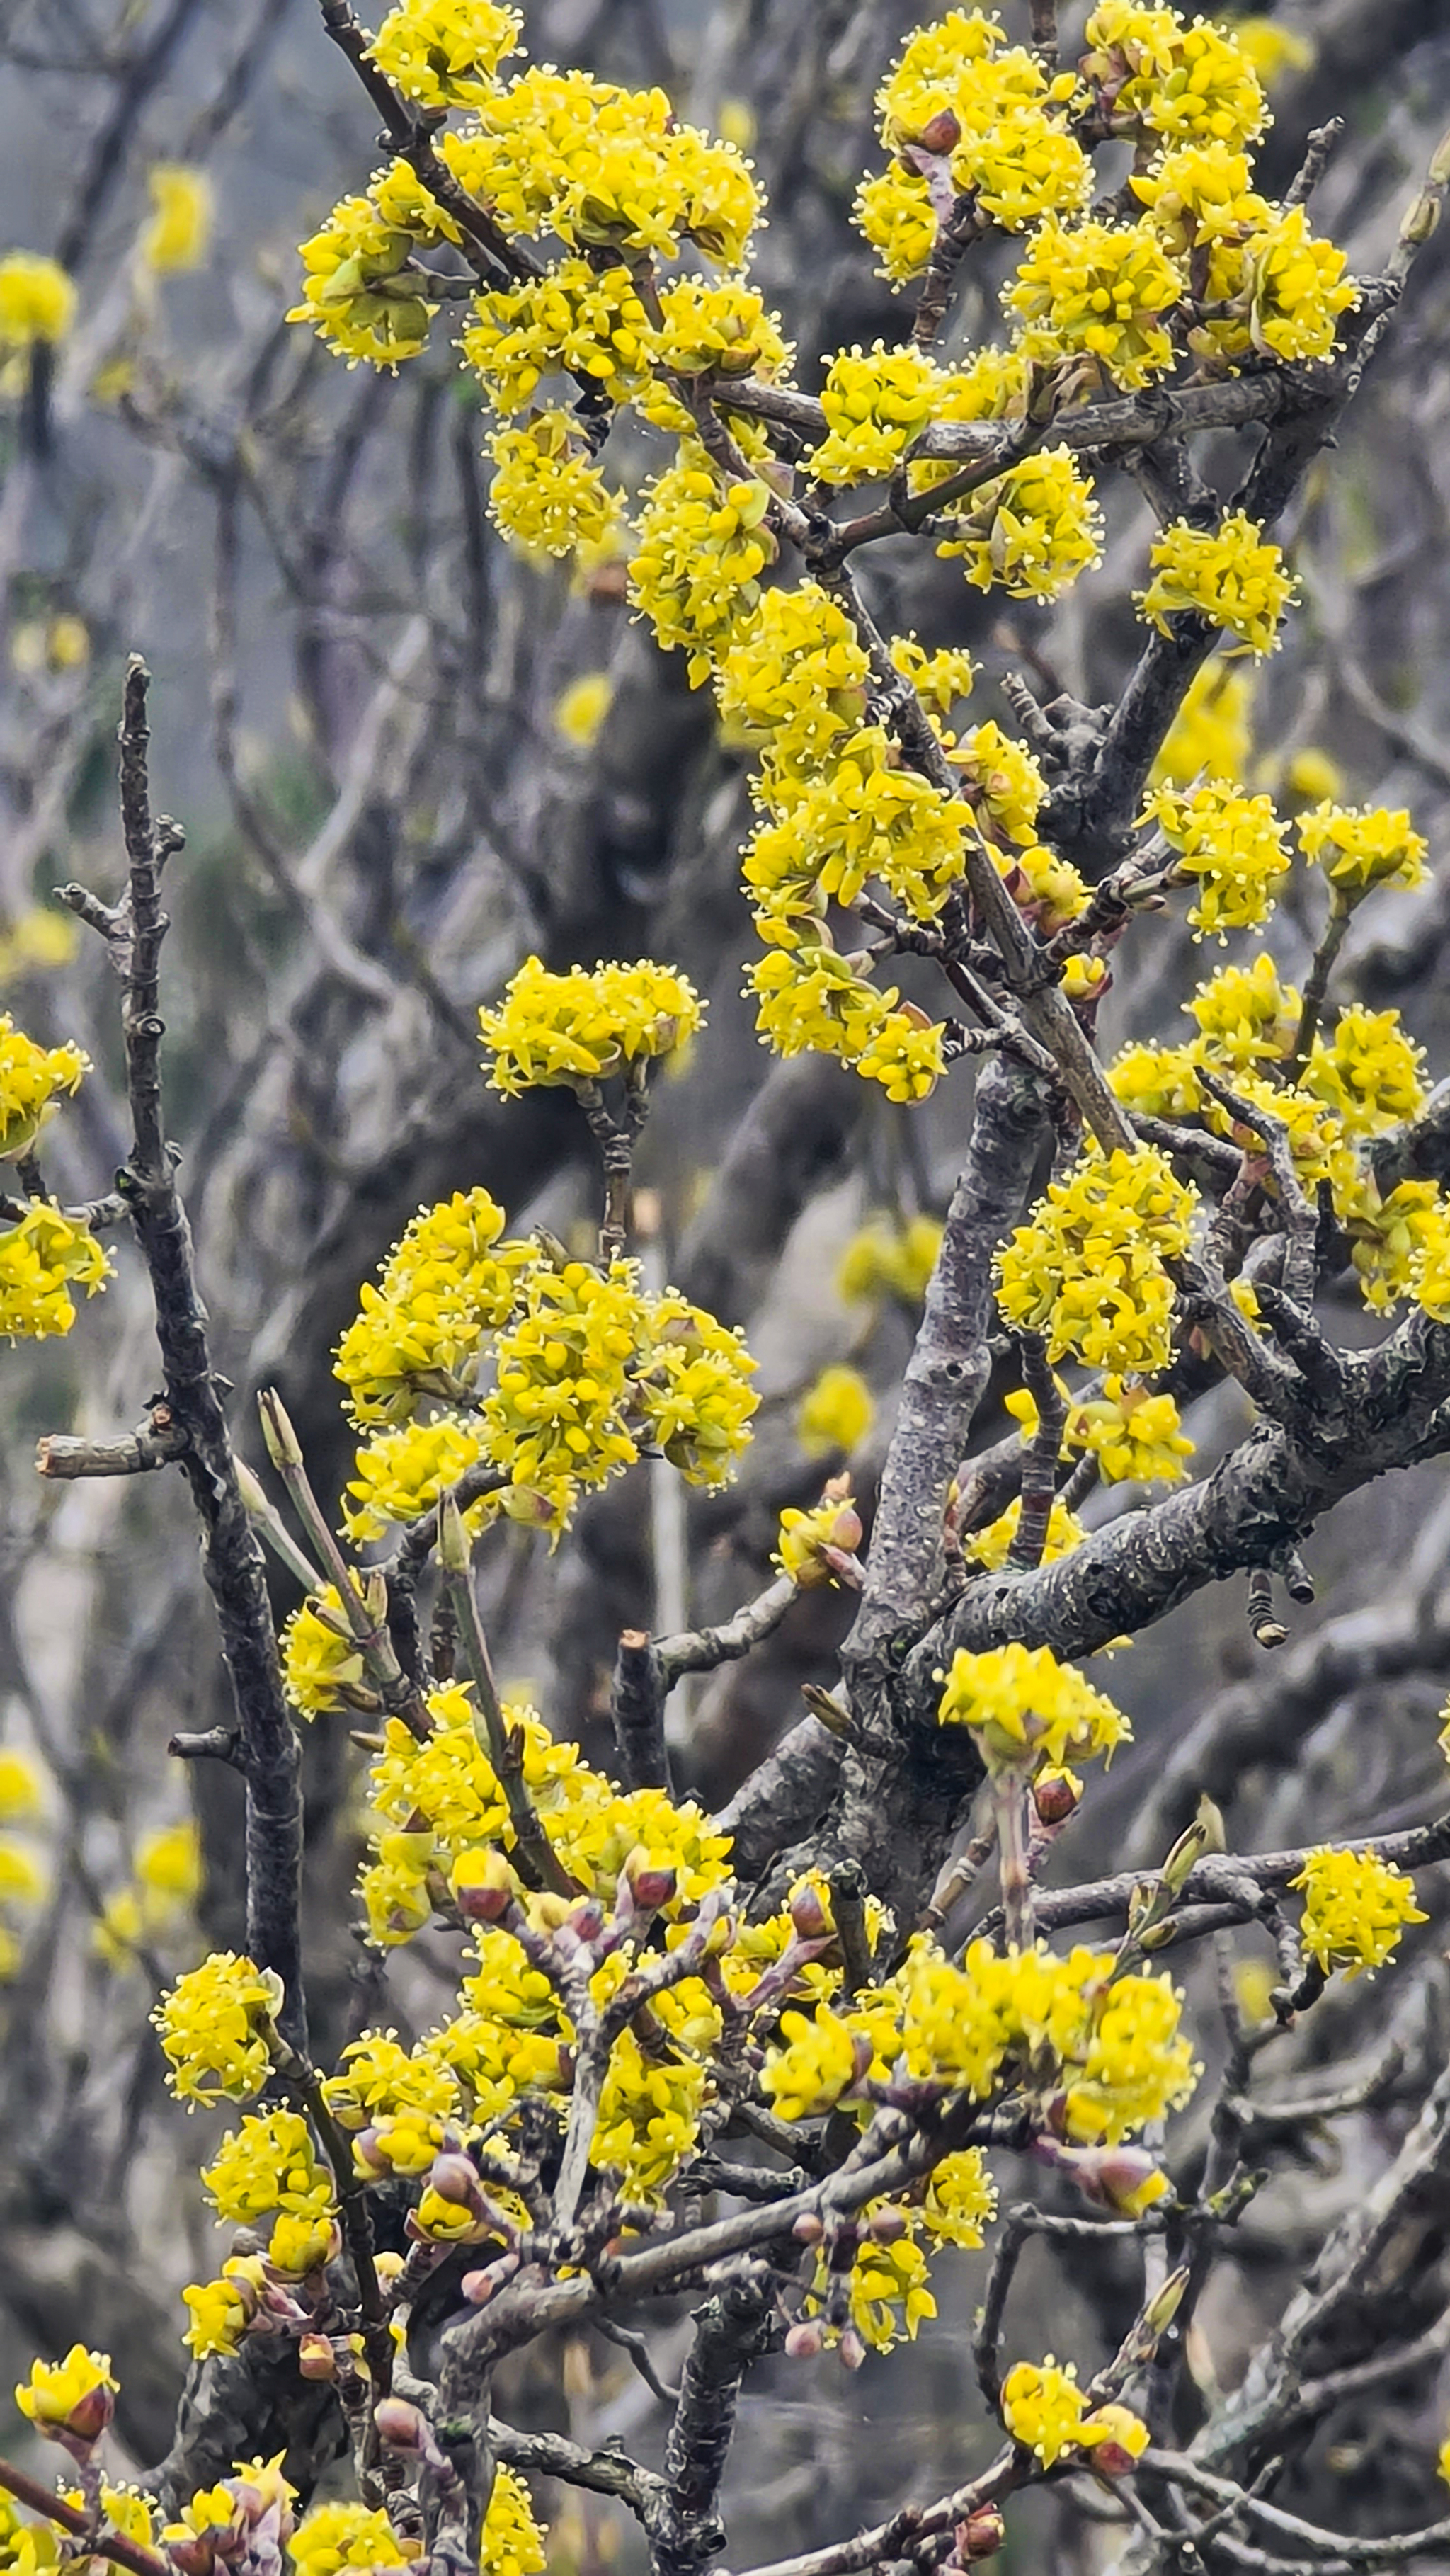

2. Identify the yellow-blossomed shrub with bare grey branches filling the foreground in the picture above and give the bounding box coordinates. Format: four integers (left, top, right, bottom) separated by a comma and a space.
0, 0, 1450, 2576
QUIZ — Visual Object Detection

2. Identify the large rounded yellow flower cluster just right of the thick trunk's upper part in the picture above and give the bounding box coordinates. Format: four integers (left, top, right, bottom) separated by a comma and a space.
997, 1151, 1198, 1376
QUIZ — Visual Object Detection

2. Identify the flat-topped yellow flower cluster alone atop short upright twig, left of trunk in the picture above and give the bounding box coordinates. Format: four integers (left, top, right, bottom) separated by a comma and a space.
479, 958, 703, 1100
